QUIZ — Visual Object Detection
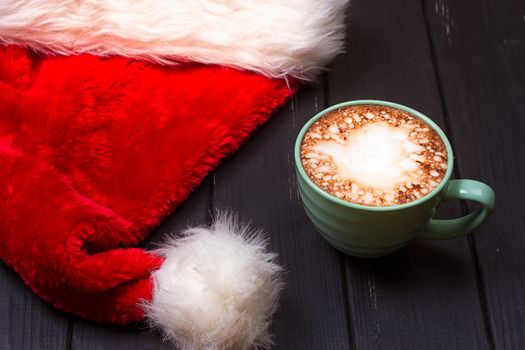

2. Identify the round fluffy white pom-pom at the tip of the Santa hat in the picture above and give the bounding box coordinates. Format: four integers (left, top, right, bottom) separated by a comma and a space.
144, 215, 282, 350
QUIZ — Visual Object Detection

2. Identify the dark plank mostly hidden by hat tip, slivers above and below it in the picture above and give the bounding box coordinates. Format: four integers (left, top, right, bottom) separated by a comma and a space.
72, 177, 211, 350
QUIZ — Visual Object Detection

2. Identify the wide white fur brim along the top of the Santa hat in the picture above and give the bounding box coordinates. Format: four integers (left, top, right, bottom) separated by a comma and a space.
0, 0, 348, 80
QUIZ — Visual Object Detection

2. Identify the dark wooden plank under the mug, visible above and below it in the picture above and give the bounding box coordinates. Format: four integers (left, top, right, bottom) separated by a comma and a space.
329, 0, 489, 350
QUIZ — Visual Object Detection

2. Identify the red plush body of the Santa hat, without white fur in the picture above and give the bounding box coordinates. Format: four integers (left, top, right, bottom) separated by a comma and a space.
0, 46, 294, 323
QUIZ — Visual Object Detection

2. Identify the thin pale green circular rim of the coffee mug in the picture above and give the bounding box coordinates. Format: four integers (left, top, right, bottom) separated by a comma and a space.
294, 99, 454, 211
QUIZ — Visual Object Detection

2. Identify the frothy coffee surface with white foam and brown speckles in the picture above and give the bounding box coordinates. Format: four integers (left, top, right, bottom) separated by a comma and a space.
301, 105, 448, 206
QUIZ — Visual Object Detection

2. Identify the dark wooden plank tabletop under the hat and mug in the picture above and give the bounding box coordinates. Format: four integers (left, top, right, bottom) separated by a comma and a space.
0, 0, 525, 350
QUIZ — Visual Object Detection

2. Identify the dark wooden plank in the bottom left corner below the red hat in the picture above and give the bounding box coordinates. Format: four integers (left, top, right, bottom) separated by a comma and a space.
0, 264, 71, 350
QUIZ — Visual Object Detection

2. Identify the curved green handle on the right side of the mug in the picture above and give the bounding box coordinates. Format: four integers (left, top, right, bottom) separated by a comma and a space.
417, 180, 495, 239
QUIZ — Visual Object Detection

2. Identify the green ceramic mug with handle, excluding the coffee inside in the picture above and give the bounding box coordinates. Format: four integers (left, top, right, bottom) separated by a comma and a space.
294, 100, 494, 257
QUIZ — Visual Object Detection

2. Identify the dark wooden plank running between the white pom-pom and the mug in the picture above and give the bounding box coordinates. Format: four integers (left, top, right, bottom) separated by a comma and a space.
213, 85, 350, 349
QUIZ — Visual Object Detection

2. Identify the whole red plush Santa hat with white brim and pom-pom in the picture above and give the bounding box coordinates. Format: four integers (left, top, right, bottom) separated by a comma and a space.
0, 0, 347, 349
